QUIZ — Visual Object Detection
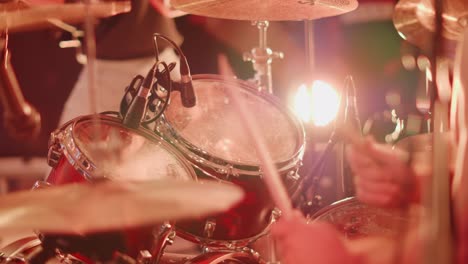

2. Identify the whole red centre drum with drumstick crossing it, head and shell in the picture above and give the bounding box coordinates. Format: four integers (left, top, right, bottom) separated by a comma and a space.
157, 75, 305, 246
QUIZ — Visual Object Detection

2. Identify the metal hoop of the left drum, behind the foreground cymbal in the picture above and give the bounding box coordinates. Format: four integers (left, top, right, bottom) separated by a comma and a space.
54, 114, 197, 182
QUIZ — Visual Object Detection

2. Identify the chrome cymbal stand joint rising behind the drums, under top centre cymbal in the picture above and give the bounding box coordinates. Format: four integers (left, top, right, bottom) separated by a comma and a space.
243, 21, 284, 94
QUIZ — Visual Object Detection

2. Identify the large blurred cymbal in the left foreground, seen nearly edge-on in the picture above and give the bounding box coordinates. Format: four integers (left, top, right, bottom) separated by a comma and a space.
0, 181, 243, 235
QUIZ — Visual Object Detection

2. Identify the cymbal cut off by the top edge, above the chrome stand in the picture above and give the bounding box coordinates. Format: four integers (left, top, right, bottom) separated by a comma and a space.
171, 0, 358, 21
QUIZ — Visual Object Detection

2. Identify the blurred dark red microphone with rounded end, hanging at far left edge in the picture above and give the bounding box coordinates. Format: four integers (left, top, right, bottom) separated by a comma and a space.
0, 44, 41, 140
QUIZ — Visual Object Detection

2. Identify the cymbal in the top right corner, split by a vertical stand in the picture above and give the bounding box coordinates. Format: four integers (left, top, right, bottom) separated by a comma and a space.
393, 0, 468, 52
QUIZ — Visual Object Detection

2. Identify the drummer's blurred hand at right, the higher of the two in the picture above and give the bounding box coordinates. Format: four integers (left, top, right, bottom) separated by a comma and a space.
346, 138, 419, 207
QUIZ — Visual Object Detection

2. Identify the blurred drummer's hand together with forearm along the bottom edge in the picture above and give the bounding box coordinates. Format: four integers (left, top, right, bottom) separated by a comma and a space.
272, 210, 424, 264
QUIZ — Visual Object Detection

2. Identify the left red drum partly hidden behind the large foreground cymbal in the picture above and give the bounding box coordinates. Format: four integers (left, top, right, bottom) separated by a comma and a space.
43, 115, 196, 257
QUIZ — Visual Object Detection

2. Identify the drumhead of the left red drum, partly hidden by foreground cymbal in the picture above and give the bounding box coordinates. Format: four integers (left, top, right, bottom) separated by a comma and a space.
66, 118, 195, 181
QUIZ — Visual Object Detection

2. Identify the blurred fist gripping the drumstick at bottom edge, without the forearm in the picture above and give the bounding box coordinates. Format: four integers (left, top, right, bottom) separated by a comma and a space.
272, 212, 359, 264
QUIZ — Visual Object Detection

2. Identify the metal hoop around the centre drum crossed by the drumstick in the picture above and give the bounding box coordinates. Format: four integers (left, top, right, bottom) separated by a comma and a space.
156, 74, 305, 176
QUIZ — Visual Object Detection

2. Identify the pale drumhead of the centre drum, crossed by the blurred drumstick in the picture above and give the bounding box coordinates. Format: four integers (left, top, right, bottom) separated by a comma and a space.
165, 75, 303, 166
